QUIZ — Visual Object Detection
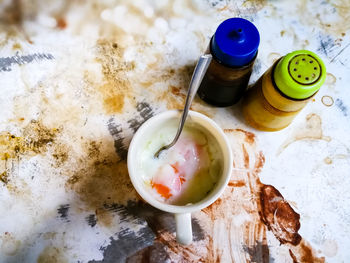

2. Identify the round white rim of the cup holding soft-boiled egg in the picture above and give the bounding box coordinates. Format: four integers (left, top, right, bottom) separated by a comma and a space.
127, 110, 233, 216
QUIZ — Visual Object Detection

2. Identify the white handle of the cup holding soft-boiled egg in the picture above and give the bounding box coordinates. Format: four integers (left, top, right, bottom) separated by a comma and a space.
175, 213, 192, 245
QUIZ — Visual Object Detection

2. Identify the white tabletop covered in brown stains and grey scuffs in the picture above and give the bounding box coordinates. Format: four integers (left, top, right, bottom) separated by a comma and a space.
0, 0, 350, 263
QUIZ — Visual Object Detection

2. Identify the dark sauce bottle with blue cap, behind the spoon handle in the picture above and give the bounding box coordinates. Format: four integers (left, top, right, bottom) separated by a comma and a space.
198, 18, 260, 107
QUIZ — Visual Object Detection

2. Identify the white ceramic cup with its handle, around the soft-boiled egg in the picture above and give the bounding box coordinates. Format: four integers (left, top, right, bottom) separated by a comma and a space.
127, 110, 233, 245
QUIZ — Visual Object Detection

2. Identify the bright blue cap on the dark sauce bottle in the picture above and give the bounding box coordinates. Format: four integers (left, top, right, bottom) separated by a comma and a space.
211, 17, 260, 67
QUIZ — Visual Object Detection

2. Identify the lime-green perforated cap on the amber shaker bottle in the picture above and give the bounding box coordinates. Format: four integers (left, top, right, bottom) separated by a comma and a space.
274, 50, 326, 99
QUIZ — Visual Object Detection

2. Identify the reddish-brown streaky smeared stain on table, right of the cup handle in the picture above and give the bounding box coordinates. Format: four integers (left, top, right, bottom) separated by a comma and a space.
152, 129, 324, 262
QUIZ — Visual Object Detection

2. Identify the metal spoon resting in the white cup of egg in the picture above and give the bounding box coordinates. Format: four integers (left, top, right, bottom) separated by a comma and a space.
154, 54, 212, 158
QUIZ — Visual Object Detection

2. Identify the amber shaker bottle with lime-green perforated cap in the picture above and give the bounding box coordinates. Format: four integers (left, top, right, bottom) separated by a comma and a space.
242, 50, 326, 131
